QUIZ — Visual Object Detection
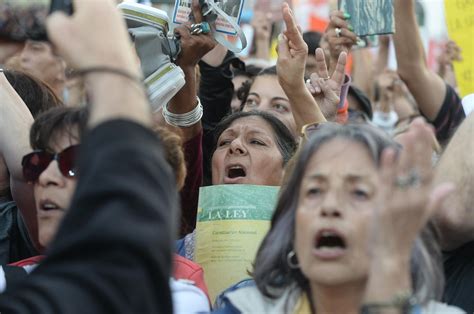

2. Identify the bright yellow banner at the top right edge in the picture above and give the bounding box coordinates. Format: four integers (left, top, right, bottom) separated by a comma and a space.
444, 0, 474, 96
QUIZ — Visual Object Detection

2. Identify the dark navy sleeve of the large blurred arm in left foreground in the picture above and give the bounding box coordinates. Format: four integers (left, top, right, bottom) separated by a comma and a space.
0, 120, 177, 313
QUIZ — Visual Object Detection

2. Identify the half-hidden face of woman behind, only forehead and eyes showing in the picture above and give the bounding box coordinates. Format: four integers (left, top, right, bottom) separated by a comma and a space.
243, 75, 296, 133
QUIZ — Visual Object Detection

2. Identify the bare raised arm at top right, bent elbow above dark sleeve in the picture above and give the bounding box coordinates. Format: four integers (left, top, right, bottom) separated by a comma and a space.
393, 0, 446, 121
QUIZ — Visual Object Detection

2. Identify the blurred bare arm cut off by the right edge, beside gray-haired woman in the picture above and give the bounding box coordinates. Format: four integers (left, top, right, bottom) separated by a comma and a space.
435, 114, 474, 250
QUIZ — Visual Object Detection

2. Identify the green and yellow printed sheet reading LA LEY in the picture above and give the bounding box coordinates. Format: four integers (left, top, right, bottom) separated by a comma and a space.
194, 184, 279, 301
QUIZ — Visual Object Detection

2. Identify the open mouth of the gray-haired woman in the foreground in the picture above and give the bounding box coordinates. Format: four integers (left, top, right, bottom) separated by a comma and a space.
314, 230, 346, 259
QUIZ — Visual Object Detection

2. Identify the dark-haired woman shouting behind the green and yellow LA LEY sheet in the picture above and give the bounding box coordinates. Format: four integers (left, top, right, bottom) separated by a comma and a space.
176, 111, 297, 260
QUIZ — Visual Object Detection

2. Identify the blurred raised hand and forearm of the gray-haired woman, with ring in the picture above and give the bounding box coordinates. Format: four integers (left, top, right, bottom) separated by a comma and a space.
365, 118, 454, 313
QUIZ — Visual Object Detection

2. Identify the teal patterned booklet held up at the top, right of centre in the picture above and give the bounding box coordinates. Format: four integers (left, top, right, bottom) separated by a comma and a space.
339, 0, 395, 36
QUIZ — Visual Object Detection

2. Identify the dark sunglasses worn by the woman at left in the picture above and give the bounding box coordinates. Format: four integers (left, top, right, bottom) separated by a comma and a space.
21, 145, 79, 183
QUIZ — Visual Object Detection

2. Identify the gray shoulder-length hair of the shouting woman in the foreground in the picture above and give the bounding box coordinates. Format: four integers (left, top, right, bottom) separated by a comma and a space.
252, 123, 444, 303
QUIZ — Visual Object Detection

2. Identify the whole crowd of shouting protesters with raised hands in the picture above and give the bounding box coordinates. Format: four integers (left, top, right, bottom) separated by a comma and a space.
0, 0, 474, 313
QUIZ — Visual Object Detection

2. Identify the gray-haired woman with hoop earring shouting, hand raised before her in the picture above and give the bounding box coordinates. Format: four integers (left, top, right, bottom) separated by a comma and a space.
216, 120, 461, 313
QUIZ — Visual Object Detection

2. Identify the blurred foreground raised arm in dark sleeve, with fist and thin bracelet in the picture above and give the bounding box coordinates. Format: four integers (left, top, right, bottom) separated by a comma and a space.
0, 0, 176, 313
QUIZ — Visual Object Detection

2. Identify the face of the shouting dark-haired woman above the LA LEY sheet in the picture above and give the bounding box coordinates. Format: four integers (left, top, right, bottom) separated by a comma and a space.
212, 116, 283, 185
